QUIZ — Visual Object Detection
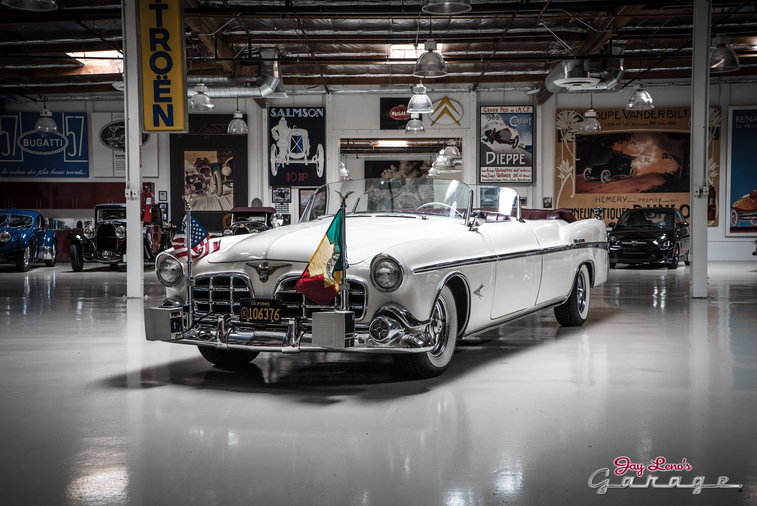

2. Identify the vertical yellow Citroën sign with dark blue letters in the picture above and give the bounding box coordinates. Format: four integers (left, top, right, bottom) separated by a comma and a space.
139, 0, 187, 132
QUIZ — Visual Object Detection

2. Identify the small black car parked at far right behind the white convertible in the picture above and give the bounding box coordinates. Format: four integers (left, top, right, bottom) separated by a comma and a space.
608, 207, 691, 269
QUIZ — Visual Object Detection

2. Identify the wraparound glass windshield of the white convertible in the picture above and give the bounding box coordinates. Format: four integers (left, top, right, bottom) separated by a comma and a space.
300, 178, 472, 222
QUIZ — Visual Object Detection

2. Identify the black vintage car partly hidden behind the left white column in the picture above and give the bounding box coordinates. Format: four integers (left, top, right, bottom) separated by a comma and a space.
69, 204, 174, 272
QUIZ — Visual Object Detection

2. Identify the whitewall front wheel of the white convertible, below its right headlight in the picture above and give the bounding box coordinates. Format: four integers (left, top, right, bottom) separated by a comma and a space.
394, 286, 457, 378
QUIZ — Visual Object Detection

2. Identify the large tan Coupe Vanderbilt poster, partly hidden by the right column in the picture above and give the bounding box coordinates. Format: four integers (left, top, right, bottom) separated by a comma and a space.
555, 107, 721, 226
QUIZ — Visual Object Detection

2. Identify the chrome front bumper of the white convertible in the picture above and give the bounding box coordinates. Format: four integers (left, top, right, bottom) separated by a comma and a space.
145, 306, 435, 353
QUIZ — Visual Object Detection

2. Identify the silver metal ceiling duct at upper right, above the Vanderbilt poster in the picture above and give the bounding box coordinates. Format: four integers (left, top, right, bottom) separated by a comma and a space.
544, 42, 625, 93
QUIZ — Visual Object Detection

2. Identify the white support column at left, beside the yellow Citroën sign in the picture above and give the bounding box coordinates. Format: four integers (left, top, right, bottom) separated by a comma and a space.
121, 0, 145, 299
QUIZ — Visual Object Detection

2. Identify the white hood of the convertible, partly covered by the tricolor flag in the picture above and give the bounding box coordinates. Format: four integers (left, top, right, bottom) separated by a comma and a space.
208, 215, 463, 264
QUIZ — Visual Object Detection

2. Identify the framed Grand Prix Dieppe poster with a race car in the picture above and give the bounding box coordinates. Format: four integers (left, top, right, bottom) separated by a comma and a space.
479, 105, 534, 183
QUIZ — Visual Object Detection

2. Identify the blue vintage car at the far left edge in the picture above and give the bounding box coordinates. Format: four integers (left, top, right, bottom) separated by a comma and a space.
0, 209, 58, 272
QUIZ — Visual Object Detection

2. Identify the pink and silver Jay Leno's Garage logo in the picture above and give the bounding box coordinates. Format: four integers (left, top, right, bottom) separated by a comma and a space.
589, 456, 743, 495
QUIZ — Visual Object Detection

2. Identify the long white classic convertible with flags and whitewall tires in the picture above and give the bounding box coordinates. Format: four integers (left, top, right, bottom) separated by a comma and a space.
145, 179, 608, 377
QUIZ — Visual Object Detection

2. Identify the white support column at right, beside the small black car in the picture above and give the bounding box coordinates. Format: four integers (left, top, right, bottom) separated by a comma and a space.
690, 0, 712, 298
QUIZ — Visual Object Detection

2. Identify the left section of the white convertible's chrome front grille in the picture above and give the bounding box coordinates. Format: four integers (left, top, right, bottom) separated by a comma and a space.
192, 273, 252, 316
